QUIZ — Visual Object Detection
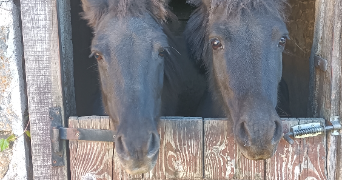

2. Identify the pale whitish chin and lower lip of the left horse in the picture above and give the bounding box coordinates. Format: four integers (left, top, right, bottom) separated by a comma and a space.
118, 152, 159, 175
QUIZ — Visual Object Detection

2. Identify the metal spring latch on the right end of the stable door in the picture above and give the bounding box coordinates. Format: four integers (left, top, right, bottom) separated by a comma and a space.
284, 116, 341, 144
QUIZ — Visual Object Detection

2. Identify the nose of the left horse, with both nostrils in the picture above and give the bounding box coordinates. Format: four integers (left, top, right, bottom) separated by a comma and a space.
115, 132, 160, 164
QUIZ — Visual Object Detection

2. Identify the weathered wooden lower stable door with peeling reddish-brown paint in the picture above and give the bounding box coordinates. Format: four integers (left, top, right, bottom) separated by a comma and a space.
69, 116, 326, 180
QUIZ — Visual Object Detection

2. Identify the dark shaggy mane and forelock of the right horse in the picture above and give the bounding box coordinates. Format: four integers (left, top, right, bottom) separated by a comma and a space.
184, 0, 287, 61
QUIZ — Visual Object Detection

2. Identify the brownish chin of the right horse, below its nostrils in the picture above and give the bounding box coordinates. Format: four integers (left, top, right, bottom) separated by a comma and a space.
238, 143, 278, 160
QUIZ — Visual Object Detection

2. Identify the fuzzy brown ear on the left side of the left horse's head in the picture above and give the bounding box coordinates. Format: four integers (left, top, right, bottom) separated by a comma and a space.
81, 0, 109, 28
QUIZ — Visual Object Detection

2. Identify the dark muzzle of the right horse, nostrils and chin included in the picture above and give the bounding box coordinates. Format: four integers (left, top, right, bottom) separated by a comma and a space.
235, 119, 282, 160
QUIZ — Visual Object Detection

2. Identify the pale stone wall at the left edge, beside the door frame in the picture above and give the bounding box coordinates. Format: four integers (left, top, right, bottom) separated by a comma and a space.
0, 0, 32, 180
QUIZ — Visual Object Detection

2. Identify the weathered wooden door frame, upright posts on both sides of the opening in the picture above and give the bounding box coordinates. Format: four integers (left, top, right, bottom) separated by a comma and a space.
20, 0, 342, 180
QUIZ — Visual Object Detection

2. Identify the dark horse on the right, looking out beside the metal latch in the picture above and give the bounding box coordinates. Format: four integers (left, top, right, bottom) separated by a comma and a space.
184, 0, 289, 160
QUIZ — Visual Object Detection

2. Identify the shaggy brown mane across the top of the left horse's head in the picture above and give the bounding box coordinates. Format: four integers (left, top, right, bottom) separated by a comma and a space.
81, 0, 170, 27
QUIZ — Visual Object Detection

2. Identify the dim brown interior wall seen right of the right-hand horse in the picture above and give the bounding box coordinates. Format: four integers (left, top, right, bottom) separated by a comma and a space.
283, 0, 315, 117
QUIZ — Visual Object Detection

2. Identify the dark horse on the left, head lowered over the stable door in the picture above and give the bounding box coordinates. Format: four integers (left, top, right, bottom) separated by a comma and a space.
82, 0, 203, 174
